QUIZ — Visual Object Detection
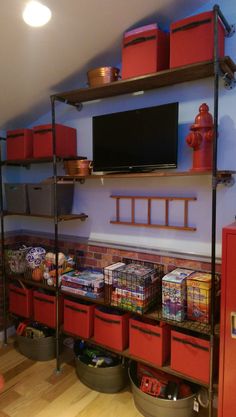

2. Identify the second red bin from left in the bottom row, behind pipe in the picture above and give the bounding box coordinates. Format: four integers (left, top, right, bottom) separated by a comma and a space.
33, 291, 63, 327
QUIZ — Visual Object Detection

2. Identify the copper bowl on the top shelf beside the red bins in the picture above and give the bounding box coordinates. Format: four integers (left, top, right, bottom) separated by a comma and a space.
87, 67, 120, 87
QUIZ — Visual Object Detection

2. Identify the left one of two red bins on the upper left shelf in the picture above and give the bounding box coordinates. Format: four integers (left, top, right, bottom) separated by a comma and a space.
7, 129, 33, 160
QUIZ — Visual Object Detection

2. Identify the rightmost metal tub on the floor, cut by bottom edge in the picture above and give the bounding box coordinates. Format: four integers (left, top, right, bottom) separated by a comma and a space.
129, 363, 196, 417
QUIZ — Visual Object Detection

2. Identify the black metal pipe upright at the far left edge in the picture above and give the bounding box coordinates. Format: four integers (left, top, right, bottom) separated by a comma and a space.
0, 138, 7, 345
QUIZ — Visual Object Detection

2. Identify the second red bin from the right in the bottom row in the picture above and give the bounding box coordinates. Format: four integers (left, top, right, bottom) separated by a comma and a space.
129, 319, 170, 366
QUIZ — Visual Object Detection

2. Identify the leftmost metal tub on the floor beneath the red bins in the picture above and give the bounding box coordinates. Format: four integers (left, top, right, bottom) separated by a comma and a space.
16, 335, 56, 361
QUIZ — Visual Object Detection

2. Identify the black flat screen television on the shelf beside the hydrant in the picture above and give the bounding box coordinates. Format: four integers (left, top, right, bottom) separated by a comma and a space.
93, 103, 178, 172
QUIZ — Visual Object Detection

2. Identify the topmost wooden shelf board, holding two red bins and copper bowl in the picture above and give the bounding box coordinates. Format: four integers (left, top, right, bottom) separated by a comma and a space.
51, 56, 236, 105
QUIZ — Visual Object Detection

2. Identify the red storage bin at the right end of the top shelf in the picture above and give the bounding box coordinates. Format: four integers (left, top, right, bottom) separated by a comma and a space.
170, 11, 225, 68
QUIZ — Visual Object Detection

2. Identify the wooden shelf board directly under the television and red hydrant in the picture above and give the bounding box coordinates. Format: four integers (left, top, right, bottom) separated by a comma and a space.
58, 170, 235, 183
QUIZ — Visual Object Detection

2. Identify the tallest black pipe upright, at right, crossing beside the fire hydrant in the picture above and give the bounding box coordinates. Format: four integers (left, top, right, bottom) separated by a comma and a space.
209, 5, 219, 417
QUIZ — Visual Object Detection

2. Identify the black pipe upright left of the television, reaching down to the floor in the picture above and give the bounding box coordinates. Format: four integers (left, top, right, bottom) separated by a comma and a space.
51, 97, 60, 372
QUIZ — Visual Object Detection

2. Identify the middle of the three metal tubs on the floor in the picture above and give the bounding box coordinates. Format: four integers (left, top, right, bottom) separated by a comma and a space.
75, 358, 128, 393
